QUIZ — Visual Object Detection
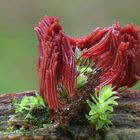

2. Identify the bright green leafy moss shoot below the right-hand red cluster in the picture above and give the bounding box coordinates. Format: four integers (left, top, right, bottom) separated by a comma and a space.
86, 85, 118, 130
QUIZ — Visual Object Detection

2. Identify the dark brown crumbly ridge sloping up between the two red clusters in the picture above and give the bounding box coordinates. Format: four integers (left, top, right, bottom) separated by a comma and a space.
58, 72, 99, 125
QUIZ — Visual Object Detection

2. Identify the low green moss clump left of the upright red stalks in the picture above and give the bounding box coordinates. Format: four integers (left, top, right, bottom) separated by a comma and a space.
12, 93, 50, 127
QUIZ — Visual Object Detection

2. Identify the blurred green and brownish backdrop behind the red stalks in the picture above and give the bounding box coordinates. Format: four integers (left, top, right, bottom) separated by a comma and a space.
0, 0, 140, 93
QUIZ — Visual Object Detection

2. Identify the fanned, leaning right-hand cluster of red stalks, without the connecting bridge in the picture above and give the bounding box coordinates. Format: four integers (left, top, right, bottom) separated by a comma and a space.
83, 23, 140, 89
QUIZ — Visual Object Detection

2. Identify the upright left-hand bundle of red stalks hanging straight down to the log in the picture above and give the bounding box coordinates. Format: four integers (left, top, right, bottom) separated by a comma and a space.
35, 17, 76, 109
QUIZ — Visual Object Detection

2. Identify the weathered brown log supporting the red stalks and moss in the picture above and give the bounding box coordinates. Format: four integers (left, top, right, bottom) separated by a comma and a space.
0, 90, 140, 140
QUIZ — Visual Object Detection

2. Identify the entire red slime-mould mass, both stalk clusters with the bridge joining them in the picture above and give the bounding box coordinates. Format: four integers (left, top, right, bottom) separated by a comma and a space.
35, 16, 140, 110
